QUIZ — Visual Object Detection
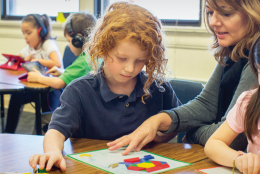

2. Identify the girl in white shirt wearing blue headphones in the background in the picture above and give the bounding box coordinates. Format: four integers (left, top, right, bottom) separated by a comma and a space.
19, 14, 62, 68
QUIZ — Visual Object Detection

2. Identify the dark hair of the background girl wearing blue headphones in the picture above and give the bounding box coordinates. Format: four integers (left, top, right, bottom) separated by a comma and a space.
22, 14, 53, 41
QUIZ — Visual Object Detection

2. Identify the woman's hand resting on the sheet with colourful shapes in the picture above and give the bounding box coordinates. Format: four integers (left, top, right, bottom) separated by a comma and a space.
107, 113, 171, 155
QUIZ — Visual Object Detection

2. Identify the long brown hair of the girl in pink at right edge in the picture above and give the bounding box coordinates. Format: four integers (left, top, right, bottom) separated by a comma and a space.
244, 35, 260, 143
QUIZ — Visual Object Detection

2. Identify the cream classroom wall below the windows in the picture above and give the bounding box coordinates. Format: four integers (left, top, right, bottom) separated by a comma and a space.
0, 0, 216, 111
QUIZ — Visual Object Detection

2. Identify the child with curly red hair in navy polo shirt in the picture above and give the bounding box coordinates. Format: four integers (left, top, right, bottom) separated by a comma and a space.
29, 3, 181, 171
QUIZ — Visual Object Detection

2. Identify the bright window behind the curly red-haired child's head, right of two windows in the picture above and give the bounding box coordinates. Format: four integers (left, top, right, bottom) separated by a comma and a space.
95, 0, 202, 26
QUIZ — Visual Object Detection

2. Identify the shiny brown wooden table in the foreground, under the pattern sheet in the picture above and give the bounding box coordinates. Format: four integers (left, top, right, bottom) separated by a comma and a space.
0, 134, 218, 174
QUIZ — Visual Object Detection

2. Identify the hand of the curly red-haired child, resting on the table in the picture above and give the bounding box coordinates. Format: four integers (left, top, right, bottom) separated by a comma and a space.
29, 152, 66, 171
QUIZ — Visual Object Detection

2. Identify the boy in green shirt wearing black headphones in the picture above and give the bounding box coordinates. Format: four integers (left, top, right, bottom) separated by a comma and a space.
27, 12, 96, 89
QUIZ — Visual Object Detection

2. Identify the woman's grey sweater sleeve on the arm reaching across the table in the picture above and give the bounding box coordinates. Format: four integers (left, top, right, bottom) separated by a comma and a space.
162, 64, 223, 133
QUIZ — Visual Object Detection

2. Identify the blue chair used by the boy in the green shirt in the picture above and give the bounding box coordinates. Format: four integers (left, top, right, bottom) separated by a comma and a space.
33, 45, 77, 135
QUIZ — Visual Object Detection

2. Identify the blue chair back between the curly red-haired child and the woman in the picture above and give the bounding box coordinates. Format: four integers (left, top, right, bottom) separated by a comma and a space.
170, 79, 204, 143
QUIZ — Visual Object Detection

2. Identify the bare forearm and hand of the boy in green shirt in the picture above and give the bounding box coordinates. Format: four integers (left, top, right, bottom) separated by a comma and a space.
27, 69, 66, 89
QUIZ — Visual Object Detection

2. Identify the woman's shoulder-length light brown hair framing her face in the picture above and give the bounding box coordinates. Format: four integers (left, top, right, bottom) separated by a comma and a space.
203, 0, 260, 65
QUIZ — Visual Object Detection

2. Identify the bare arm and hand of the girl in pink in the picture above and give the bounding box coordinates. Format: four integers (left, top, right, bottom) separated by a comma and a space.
204, 121, 260, 173
